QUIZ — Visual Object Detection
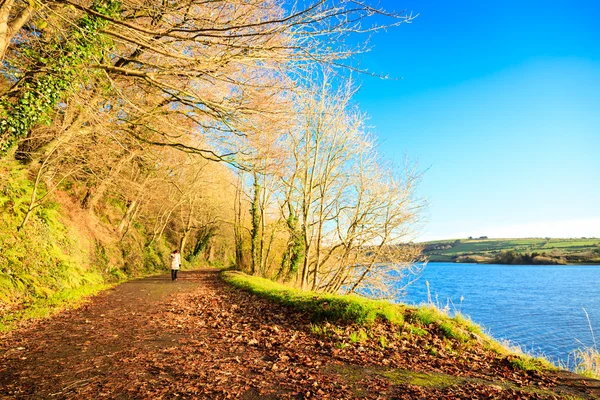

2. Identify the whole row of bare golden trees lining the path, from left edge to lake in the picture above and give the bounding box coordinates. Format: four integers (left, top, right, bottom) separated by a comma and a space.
0, 0, 422, 295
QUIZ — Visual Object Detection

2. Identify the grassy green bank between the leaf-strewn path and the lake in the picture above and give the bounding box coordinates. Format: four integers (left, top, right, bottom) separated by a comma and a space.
222, 271, 556, 371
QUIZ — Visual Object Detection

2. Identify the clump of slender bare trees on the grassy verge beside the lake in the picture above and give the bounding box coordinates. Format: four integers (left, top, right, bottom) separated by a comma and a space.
234, 73, 422, 296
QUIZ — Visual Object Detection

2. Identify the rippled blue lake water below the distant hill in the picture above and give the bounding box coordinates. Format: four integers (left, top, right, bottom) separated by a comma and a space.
398, 263, 600, 367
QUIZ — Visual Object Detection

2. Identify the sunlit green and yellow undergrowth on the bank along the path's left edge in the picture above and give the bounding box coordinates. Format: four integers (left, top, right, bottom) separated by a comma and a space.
0, 160, 170, 330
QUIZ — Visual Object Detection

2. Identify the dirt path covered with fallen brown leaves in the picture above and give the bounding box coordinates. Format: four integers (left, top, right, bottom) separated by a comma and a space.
0, 270, 600, 399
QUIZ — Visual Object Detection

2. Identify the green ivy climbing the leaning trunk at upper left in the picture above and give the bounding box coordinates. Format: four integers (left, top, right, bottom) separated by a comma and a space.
0, 0, 121, 156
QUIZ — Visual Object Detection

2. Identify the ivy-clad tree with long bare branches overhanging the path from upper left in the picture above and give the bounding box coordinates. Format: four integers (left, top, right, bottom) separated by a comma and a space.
0, 0, 412, 161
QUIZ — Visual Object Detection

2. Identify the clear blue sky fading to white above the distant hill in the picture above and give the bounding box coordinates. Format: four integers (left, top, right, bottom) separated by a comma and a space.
356, 0, 600, 240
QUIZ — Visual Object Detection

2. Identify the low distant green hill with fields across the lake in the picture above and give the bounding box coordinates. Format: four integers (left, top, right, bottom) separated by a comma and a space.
420, 236, 600, 264
